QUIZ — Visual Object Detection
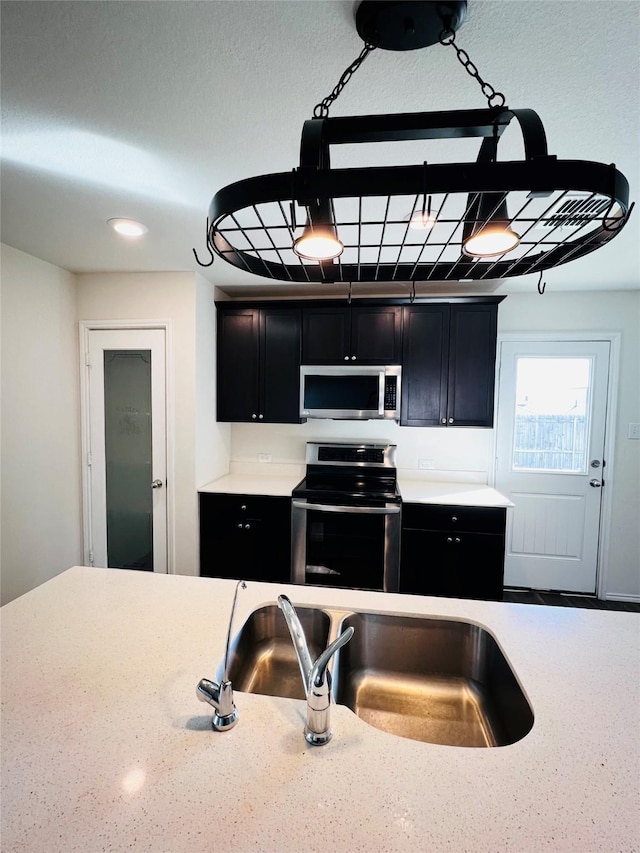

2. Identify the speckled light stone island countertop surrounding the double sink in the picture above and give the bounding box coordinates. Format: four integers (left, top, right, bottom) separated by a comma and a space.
0, 567, 640, 853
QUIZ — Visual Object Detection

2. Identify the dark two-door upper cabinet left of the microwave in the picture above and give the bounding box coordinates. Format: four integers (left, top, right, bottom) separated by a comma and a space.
217, 307, 301, 423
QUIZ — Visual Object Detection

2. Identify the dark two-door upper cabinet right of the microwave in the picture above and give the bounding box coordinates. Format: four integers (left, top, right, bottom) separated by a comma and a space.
400, 302, 498, 427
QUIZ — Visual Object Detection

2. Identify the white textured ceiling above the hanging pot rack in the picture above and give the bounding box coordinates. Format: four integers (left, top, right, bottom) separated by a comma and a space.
0, 0, 640, 296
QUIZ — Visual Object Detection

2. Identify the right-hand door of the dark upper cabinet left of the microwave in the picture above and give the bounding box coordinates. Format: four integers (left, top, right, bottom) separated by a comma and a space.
260, 308, 301, 424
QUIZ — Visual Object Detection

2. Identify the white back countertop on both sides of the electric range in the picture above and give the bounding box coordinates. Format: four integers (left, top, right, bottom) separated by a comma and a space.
199, 466, 513, 507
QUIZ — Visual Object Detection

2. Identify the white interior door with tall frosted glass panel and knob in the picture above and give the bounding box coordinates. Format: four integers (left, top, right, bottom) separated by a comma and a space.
85, 329, 167, 572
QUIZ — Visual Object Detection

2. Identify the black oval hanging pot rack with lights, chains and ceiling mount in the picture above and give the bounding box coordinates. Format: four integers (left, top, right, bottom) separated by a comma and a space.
194, 0, 633, 283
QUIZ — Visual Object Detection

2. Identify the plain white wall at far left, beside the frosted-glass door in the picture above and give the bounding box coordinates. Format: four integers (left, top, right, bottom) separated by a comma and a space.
1, 245, 82, 604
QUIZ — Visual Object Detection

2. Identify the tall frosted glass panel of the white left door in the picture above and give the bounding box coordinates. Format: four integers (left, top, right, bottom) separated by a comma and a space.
104, 350, 153, 571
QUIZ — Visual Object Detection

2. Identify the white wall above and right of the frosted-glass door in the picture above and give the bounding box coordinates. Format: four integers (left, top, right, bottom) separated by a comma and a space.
77, 272, 228, 575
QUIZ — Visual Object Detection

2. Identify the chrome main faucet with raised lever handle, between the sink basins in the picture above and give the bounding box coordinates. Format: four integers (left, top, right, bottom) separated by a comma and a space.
278, 595, 354, 746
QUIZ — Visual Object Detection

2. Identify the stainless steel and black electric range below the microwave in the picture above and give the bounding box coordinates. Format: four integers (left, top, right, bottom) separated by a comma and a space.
291, 442, 402, 592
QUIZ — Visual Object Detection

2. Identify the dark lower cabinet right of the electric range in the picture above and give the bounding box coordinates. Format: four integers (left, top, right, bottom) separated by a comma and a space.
400, 504, 506, 601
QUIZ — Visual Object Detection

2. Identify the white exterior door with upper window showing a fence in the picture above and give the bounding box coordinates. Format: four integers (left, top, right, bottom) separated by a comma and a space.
496, 341, 610, 593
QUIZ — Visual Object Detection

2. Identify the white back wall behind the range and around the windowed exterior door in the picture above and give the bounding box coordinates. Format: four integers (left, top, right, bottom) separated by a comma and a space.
231, 292, 640, 597
